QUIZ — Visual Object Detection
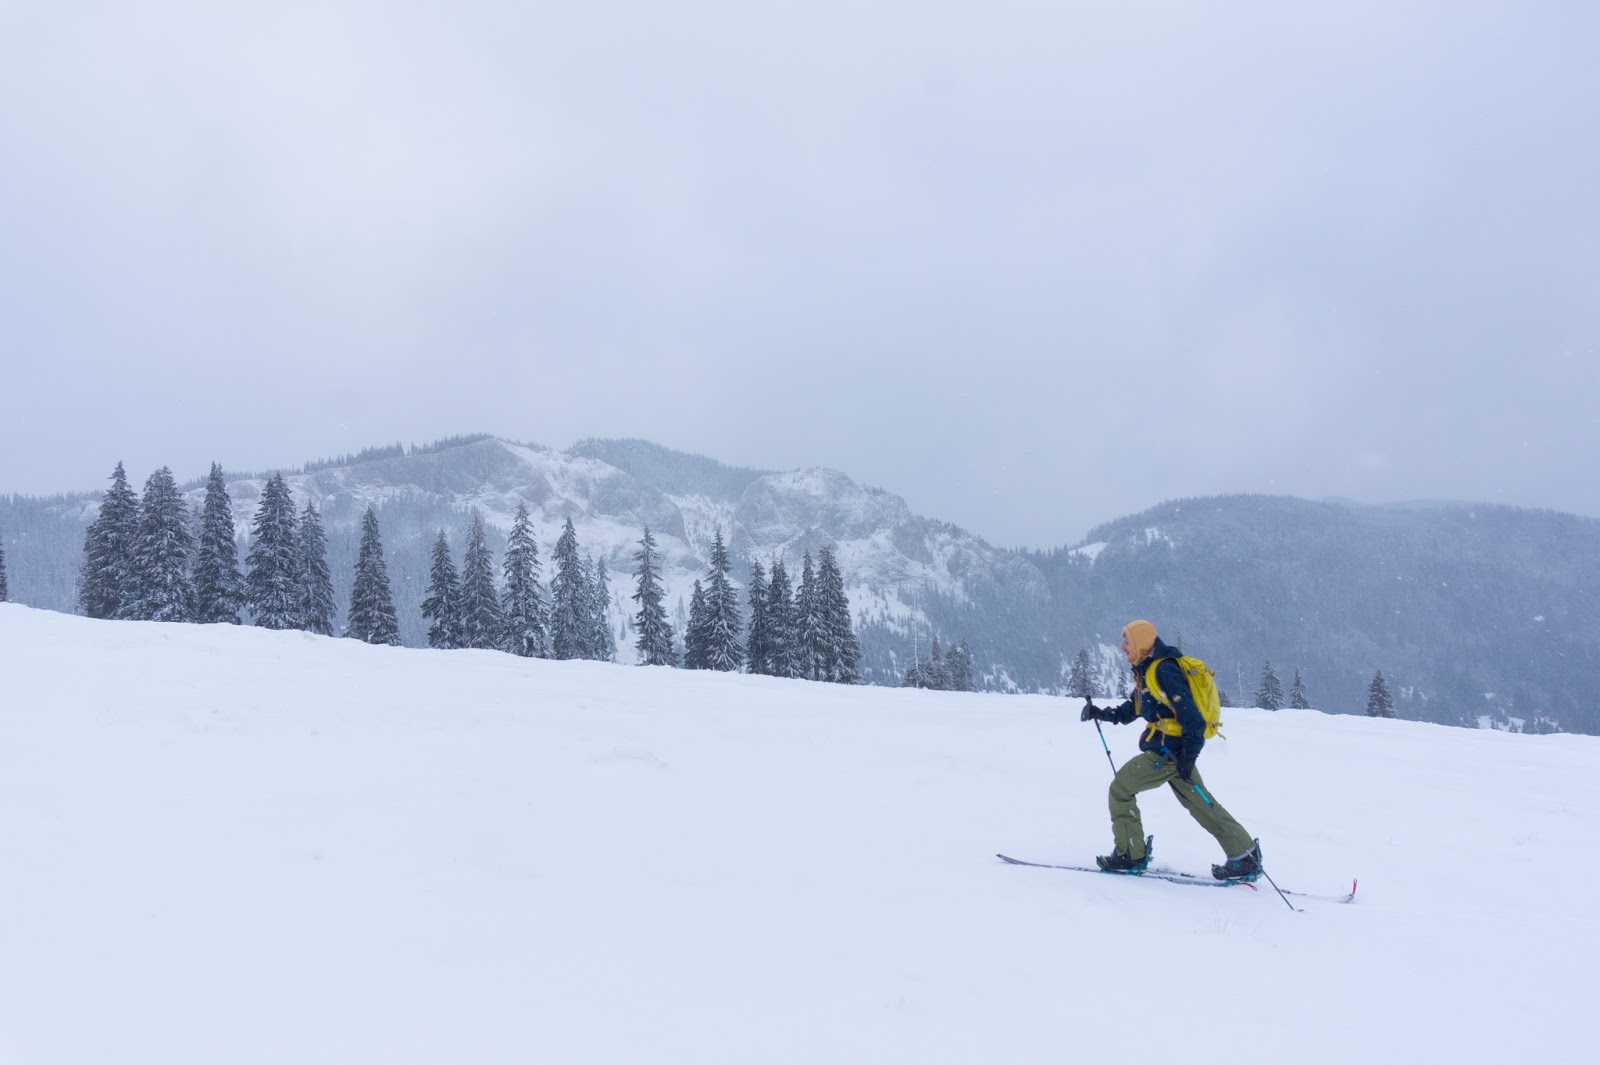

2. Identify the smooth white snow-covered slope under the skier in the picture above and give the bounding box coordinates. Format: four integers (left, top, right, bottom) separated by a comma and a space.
0, 604, 1600, 1065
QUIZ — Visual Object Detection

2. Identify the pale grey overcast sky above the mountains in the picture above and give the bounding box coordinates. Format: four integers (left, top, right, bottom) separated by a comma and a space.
0, 0, 1600, 547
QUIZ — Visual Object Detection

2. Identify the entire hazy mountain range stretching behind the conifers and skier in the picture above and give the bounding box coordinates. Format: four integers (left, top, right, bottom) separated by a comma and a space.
0, 437, 1600, 732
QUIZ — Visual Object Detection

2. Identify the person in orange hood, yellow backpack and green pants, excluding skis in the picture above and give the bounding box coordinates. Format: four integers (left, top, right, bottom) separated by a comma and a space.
1078, 620, 1261, 880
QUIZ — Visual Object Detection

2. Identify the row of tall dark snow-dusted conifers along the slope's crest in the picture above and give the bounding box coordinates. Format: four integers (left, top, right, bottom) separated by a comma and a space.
65, 462, 864, 684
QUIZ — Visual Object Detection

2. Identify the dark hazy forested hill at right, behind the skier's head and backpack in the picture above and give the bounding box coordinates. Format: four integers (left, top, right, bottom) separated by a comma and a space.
1029, 496, 1600, 732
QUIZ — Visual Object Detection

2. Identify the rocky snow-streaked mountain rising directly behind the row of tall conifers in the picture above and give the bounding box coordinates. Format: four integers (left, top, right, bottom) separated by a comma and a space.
0, 437, 1045, 681
